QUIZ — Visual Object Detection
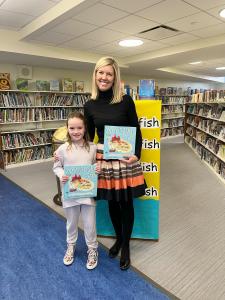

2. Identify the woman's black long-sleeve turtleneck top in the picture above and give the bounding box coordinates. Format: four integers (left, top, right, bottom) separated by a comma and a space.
84, 89, 142, 158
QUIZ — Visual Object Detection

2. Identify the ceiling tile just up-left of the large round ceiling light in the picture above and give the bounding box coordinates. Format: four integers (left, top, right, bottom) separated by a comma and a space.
79, 28, 126, 42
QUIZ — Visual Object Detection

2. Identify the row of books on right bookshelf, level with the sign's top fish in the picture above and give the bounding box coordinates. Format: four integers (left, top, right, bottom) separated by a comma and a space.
187, 115, 225, 140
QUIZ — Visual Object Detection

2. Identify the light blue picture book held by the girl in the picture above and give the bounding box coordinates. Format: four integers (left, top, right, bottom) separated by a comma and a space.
63, 165, 98, 200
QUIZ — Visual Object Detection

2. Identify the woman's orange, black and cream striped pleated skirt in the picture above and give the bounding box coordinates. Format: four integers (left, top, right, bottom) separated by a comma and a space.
96, 144, 146, 201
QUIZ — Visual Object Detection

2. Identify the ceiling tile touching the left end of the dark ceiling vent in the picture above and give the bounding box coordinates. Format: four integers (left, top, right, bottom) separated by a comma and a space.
106, 15, 158, 34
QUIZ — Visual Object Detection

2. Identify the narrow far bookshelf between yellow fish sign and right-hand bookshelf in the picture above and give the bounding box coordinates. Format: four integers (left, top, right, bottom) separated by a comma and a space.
159, 95, 188, 138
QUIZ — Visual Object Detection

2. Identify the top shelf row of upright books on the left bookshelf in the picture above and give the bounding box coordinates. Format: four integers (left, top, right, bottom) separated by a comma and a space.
0, 92, 90, 108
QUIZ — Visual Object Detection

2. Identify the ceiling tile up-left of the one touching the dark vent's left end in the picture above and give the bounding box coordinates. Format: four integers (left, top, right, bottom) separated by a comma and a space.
73, 3, 127, 26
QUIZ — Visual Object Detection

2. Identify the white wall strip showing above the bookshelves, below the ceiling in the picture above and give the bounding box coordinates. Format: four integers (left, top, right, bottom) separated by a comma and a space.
0, 64, 225, 92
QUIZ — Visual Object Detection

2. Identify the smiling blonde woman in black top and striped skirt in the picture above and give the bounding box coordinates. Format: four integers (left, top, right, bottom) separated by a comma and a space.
84, 57, 146, 270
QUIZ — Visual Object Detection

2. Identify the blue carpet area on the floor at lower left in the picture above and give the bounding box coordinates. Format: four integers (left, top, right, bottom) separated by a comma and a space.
0, 175, 169, 300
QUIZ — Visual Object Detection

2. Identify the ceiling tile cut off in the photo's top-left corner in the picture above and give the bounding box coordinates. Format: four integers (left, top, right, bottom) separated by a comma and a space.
1, 0, 57, 17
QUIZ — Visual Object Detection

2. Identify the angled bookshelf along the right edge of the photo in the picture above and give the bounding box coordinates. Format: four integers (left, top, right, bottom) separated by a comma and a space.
185, 96, 225, 183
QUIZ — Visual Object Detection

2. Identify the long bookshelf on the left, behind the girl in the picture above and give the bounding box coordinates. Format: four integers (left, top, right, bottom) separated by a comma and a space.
0, 90, 90, 169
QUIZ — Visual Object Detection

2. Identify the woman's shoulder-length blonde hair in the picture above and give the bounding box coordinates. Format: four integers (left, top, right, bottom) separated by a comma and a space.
91, 56, 122, 104
